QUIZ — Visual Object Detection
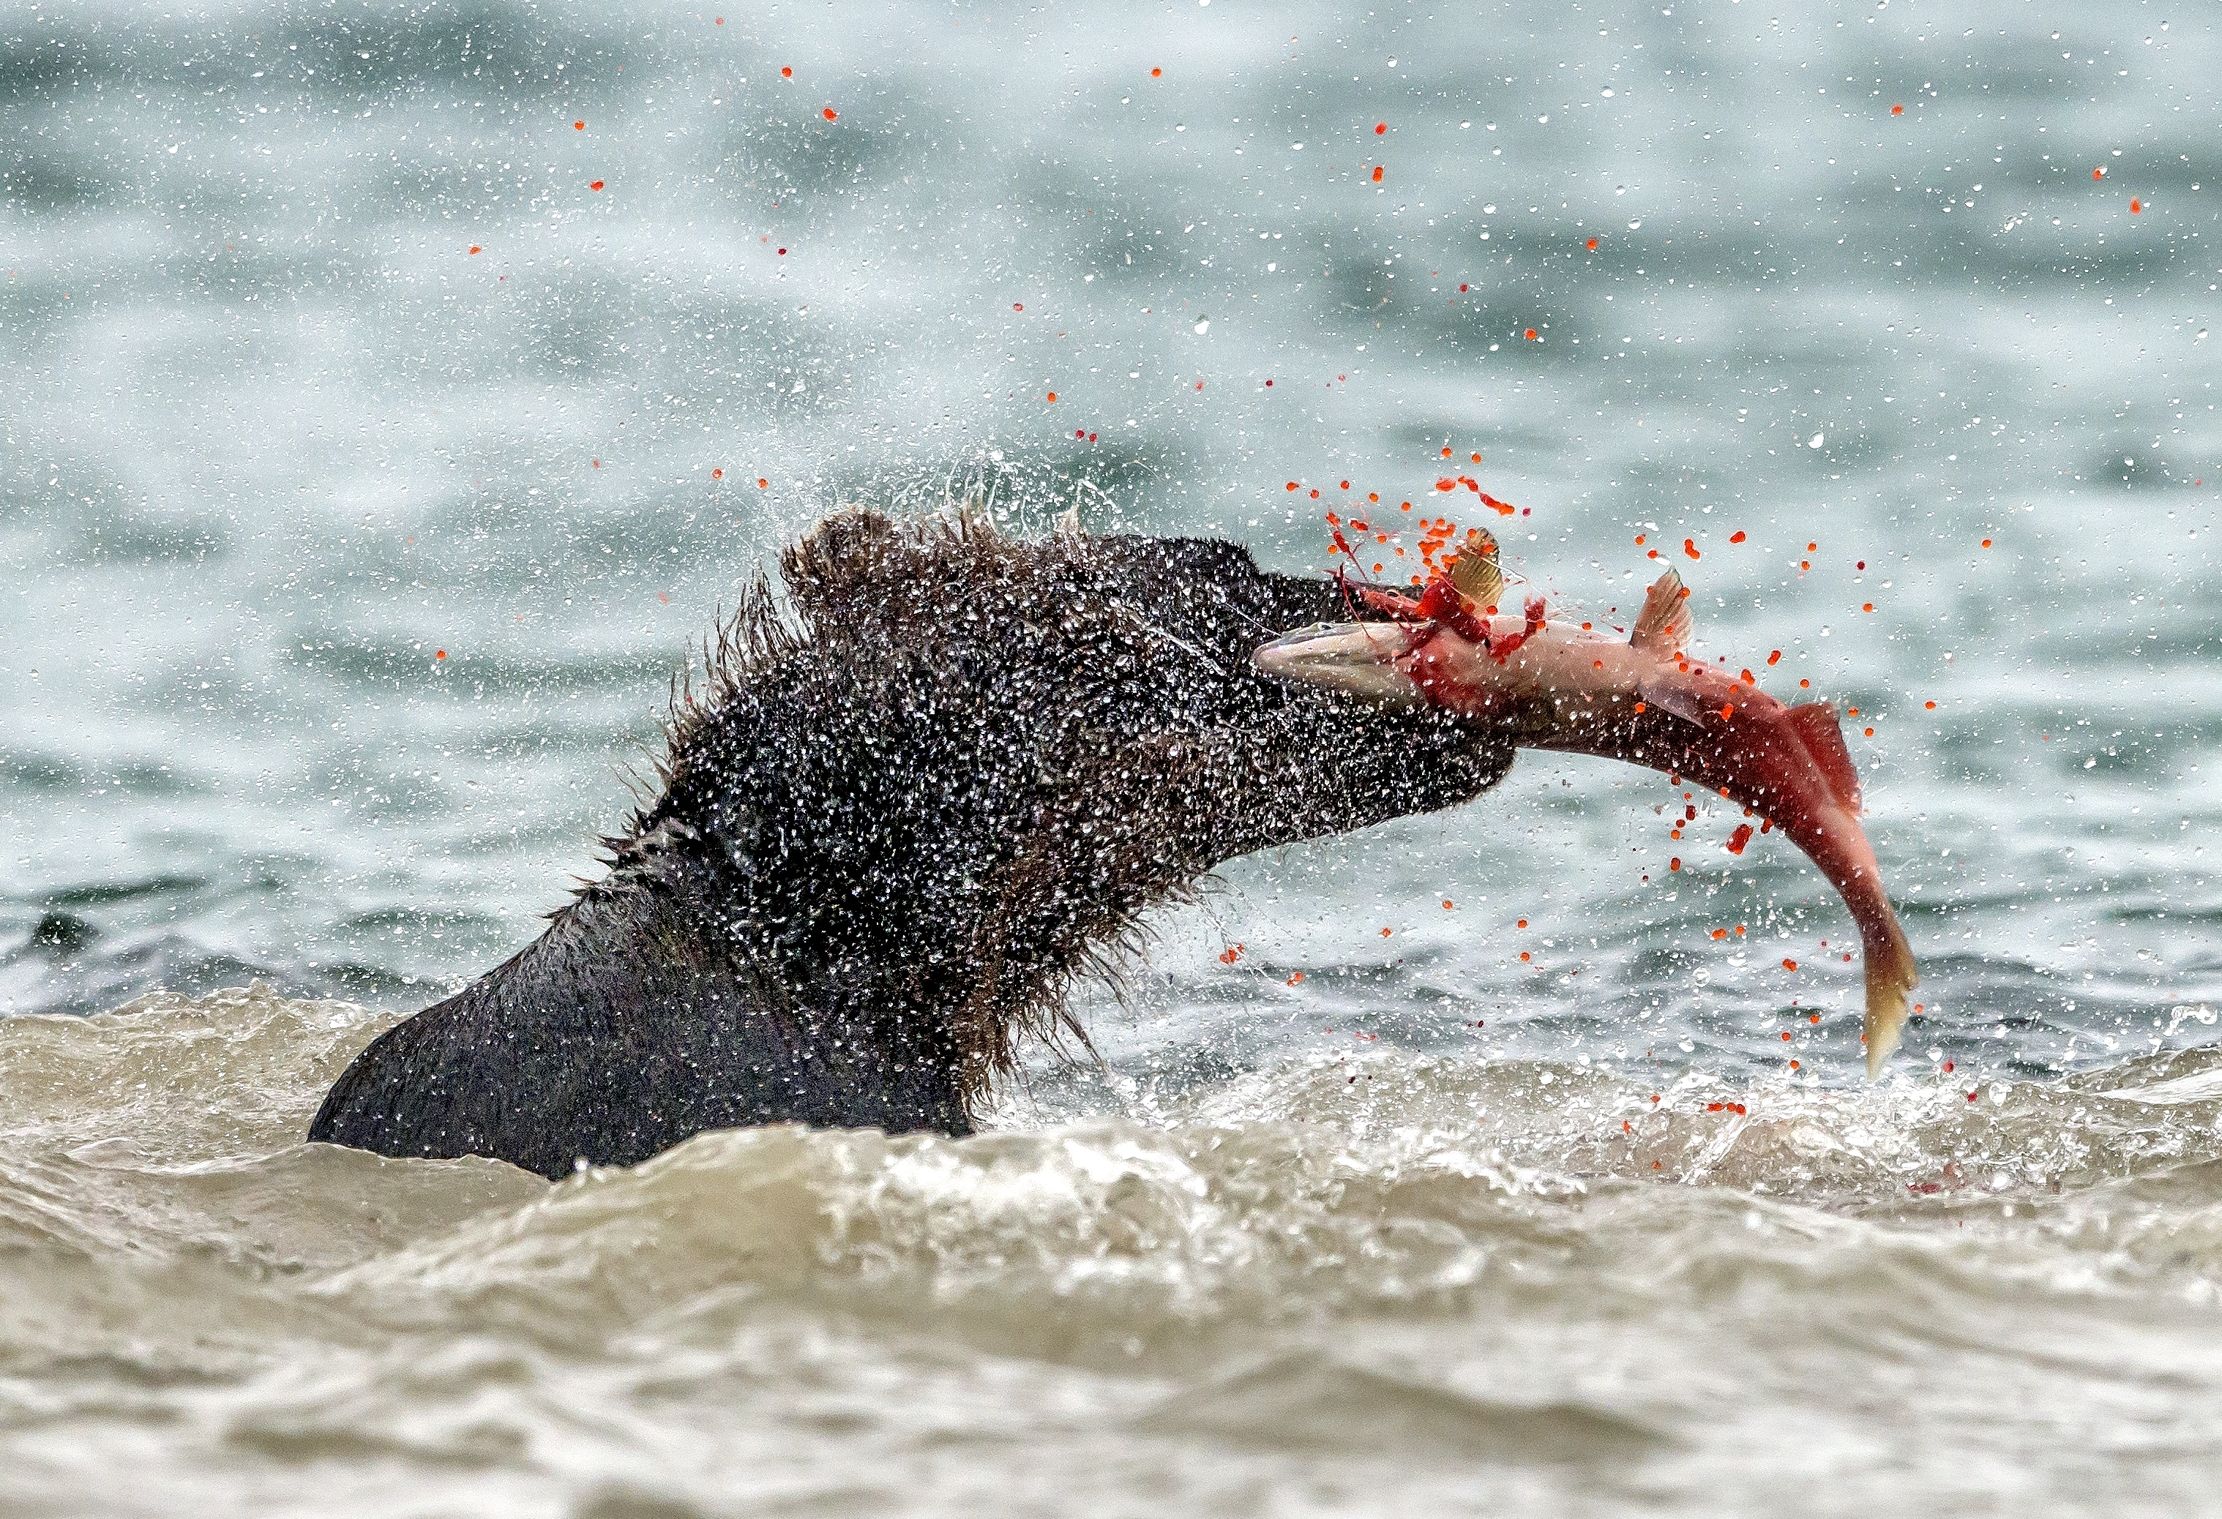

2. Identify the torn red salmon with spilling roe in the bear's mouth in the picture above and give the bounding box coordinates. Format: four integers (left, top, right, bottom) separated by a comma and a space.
1255, 531, 1920, 1077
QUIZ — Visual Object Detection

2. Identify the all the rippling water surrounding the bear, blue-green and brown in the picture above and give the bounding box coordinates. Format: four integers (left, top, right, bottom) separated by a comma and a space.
0, 0, 2222, 1515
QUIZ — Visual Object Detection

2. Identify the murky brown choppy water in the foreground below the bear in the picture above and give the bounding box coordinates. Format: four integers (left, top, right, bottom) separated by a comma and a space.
0, 990, 2222, 1515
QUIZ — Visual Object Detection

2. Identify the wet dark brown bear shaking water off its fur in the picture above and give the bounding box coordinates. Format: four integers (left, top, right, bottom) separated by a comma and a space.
309, 511, 1513, 1177
